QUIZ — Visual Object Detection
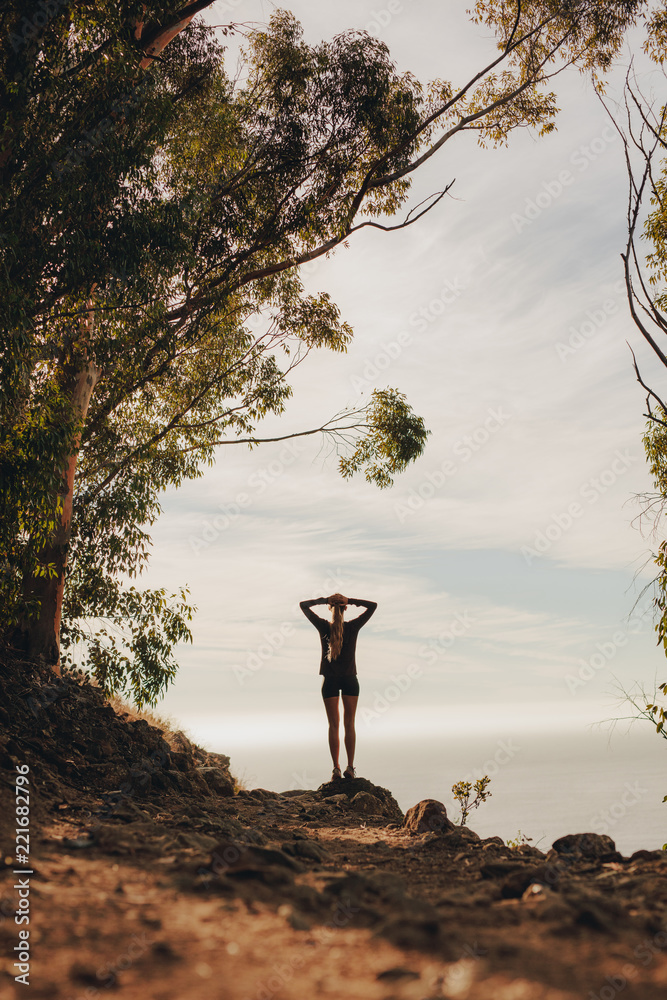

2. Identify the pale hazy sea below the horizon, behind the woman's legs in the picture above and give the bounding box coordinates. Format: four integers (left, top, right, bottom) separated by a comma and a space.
189, 725, 667, 855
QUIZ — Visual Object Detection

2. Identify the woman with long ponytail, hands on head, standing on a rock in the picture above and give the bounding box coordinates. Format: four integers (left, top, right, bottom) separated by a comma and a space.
299, 594, 377, 781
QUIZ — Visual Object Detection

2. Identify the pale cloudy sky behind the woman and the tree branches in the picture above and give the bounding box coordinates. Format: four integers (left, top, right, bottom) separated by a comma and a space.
121, 0, 667, 776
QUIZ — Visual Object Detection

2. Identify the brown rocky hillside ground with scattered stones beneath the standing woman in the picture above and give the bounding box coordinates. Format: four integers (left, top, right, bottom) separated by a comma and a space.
0, 661, 667, 1000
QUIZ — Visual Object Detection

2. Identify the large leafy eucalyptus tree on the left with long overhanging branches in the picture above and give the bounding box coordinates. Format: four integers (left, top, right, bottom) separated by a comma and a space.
0, 0, 645, 700
